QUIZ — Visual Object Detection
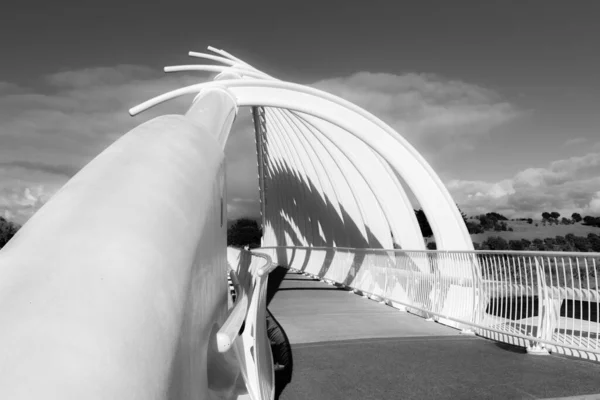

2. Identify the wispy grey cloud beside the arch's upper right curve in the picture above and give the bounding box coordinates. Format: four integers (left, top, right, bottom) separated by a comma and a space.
314, 72, 519, 153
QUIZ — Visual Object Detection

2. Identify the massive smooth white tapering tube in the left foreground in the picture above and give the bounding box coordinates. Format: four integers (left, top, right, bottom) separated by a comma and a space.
0, 93, 239, 399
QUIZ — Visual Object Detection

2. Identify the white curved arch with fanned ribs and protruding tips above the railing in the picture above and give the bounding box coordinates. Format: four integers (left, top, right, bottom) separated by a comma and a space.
130, 47, 473, 250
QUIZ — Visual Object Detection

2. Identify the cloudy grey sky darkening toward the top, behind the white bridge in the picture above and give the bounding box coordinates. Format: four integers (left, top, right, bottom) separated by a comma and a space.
0, 0, 600, 223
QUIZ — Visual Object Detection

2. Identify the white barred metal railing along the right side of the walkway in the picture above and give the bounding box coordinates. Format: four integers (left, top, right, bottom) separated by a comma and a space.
260, 247, 600, 360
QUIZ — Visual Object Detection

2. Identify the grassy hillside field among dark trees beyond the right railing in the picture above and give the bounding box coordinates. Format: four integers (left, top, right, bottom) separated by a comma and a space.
471, 221, 600, 243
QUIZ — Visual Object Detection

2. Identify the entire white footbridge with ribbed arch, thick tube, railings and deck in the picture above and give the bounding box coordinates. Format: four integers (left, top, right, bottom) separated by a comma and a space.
0, 48, 600, 399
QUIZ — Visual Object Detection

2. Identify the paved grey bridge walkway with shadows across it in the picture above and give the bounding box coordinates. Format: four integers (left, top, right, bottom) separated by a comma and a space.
269, 268, 600, 400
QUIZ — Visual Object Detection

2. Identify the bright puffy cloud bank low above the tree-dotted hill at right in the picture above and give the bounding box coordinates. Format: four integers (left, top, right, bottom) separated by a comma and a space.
446, 153, 600, 217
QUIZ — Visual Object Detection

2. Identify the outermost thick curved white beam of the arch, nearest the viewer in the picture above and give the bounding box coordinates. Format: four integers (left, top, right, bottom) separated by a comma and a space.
130, 80, 473, 250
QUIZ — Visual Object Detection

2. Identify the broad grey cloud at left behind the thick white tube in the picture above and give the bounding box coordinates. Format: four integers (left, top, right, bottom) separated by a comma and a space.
0, 65, 223, 227
